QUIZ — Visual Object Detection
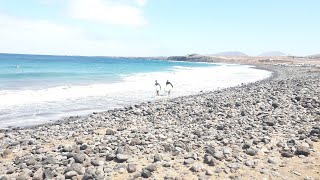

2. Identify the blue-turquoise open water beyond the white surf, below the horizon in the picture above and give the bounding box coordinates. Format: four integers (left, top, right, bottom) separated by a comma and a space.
0, 54, 213, 90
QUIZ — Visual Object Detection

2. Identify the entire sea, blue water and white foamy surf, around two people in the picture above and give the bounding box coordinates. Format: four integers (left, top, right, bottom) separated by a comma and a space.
0, 54, 271, 128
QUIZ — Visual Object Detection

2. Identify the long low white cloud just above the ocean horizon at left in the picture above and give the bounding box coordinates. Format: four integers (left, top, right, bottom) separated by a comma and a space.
0, 13, 155, 56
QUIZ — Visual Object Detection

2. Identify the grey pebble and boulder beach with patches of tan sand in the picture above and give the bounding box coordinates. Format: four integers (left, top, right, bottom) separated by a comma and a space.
0, 66, 320, 180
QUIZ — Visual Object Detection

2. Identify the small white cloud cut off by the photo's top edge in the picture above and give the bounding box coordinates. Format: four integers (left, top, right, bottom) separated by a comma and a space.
68, 0, 147, 26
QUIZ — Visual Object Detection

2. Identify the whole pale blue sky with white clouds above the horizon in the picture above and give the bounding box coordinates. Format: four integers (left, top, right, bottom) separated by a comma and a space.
0, 0, 320, 56
